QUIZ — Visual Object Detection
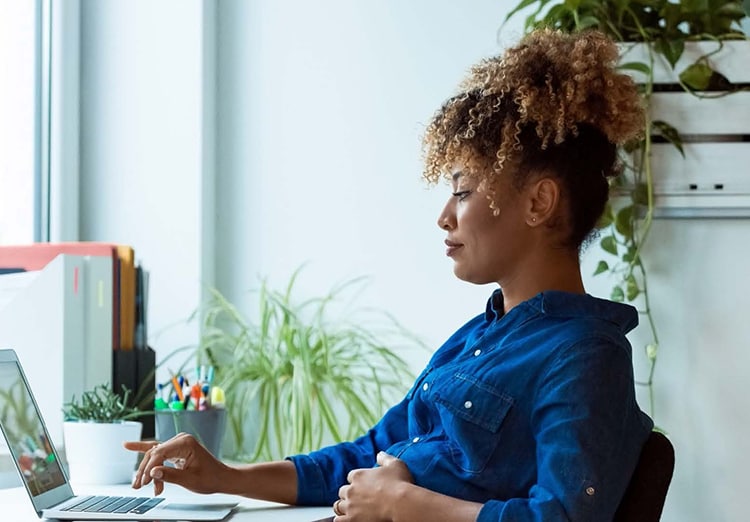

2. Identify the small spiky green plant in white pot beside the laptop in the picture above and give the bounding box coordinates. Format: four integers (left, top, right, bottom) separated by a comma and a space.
63, 384, 152, 484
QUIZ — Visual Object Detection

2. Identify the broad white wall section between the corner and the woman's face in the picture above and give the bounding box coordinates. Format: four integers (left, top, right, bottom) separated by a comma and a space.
216, 0, 517, 365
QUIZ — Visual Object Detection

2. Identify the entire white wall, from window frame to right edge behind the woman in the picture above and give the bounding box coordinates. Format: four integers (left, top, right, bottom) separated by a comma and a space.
81, 0, 750, 522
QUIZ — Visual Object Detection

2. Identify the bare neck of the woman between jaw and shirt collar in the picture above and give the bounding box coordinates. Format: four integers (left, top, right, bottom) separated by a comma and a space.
498, 245, 586, 313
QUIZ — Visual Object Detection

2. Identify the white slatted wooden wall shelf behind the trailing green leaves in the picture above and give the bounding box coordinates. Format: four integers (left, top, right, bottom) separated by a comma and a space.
621, 41, 750, 218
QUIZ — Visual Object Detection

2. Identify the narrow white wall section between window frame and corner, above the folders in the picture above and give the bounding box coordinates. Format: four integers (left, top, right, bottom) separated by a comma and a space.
80, 0, 213, 351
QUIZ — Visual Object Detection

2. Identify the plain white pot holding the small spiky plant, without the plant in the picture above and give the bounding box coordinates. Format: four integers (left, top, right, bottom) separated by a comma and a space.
63, 421, 143, 484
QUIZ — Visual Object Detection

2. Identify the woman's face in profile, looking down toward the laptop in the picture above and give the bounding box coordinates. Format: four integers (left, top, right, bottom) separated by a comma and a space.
438, 171, 531, 286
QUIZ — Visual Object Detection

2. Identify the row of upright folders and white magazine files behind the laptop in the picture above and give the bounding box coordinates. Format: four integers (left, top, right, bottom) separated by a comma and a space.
0, 242, 155, 442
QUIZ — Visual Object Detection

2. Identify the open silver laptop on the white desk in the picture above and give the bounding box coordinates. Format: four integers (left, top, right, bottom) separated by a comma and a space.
0, 350, 237, 520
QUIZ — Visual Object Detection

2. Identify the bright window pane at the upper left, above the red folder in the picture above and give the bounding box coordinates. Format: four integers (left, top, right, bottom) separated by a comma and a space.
0, 0, 42, 245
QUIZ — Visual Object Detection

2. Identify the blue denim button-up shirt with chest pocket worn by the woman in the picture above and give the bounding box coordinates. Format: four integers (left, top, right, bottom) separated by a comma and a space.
290, 290, 653, 522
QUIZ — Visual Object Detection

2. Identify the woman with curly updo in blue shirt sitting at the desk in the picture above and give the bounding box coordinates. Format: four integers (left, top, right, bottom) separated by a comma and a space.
127, 31, 653, 522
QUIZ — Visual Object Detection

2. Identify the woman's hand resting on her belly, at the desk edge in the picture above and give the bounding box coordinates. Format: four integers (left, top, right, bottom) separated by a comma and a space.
334, 451, 414, 522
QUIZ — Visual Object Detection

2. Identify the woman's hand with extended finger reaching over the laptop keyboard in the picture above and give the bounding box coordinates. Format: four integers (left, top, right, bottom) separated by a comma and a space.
124, 433, 229, 495
